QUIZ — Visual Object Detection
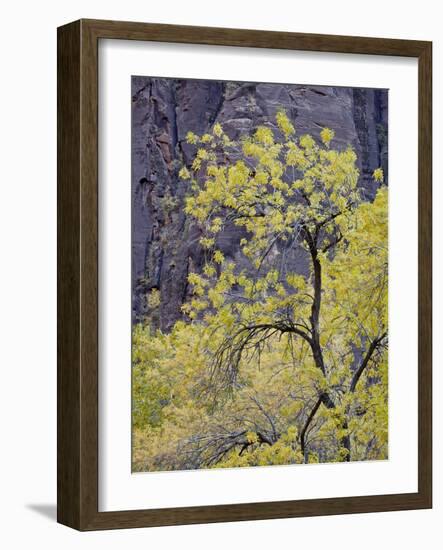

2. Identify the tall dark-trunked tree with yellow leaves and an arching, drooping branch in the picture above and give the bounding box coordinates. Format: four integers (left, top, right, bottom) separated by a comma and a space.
177, 112, 387, 468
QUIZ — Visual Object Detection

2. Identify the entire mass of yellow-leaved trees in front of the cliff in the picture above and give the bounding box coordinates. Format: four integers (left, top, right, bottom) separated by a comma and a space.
133, 111, 388, 470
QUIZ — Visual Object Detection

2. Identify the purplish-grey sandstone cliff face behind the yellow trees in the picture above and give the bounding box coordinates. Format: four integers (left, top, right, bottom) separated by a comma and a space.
132, 76, 388, 331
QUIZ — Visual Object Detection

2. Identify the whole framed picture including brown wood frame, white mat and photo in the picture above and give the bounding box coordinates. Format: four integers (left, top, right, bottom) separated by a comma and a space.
58, 20, 432, 530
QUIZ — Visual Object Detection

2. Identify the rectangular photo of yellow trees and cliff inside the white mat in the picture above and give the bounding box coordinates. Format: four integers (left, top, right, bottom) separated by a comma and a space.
132, 76, 389, 472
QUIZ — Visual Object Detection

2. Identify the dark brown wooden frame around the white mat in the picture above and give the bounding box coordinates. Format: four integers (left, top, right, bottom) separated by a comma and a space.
57, 20, 432, 531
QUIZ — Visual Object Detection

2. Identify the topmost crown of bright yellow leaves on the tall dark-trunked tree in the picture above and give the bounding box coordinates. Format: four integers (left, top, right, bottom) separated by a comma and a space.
185, 115, 359, 265
